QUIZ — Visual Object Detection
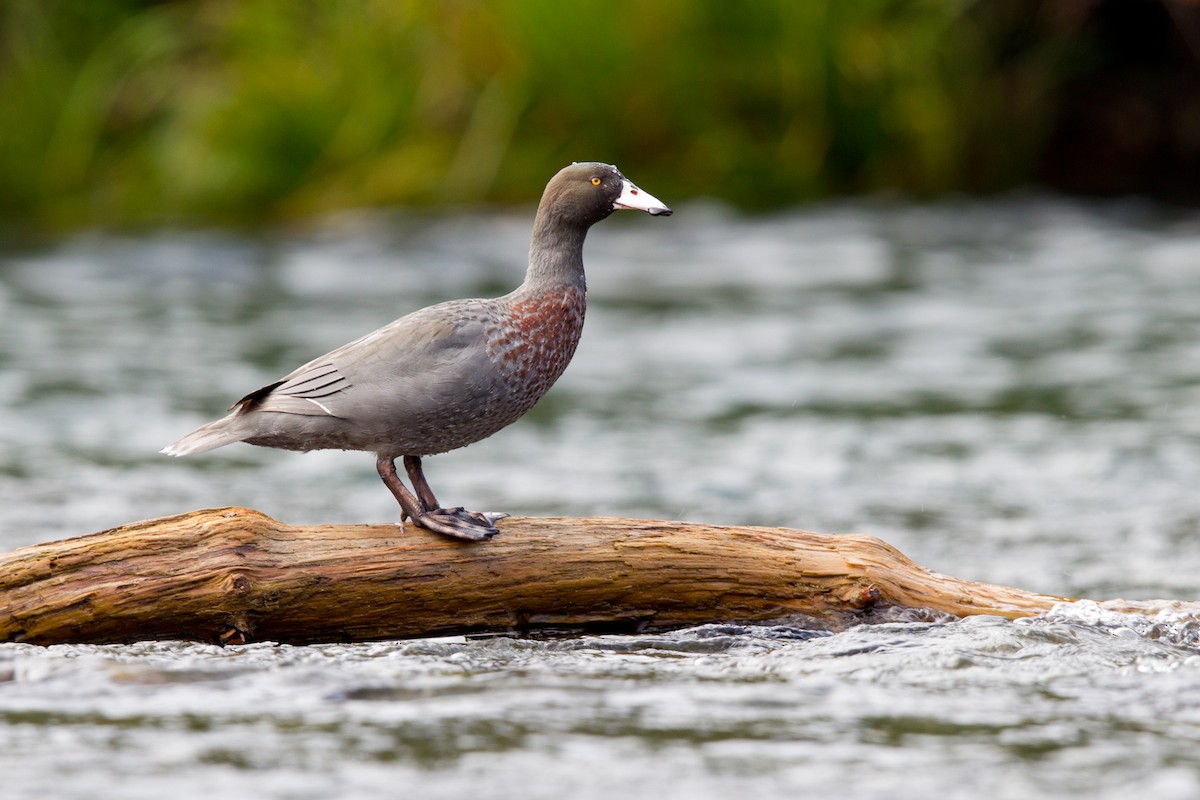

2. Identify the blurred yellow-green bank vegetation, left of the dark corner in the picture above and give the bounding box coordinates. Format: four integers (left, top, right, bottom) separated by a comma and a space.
0, 0, 1180, 228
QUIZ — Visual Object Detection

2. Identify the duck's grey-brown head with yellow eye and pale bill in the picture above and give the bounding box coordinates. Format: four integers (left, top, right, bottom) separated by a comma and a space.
538, 162, 671, 229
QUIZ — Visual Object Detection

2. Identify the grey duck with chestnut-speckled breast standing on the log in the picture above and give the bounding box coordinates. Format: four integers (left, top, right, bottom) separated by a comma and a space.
161, 162, 671, 542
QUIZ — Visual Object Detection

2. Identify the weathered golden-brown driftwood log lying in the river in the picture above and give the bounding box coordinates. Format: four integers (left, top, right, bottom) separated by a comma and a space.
0, 509, 1180, 644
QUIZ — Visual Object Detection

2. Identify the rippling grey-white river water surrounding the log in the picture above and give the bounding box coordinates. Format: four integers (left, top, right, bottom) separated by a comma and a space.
0, 196, 1200, 800
